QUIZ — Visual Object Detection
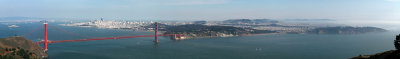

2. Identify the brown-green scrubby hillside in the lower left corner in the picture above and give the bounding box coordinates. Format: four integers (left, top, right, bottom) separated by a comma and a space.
0, 37, 47, 59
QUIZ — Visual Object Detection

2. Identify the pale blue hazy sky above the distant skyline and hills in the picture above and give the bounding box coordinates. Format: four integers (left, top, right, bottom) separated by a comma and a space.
0, 0, 400, 20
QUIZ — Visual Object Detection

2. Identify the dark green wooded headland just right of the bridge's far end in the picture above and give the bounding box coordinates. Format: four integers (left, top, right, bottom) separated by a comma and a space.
165, 24, 275, 38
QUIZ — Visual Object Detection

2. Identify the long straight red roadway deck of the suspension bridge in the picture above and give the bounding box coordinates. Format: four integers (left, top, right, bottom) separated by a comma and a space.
36, 34, 178, 44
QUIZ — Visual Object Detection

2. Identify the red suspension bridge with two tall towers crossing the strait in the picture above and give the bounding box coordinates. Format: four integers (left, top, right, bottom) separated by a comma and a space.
36, 21, 180, 52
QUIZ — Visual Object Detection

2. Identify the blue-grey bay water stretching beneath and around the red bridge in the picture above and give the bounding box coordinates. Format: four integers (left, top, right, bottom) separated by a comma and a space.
0, 23, 400, 59
